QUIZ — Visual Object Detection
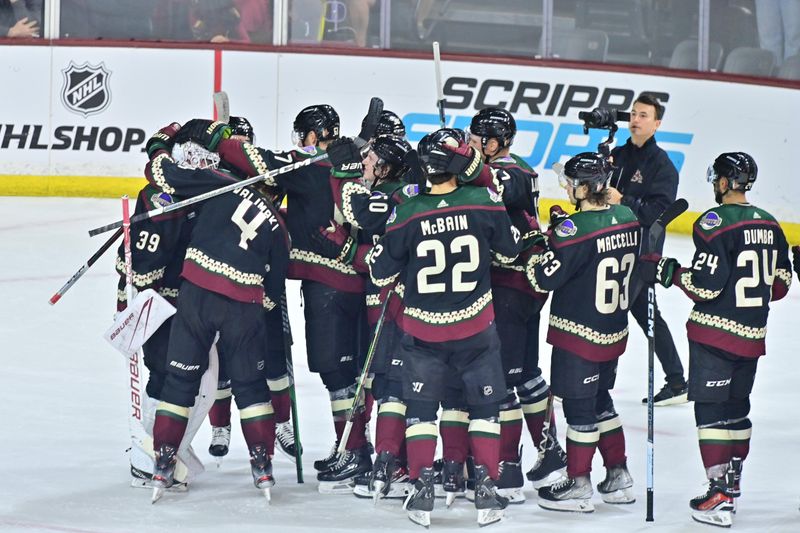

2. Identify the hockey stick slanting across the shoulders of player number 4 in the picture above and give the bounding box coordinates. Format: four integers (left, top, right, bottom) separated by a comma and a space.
89, 96, 383, 237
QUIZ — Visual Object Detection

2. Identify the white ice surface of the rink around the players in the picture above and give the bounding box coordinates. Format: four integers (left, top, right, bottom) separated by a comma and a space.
0, 198, 800, 533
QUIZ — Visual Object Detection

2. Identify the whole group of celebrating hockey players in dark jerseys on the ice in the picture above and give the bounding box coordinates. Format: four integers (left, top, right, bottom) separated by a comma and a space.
118, 92, 800, 527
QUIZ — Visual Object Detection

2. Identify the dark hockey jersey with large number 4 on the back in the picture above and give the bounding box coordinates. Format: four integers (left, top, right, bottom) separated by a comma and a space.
145, 152, 290, 310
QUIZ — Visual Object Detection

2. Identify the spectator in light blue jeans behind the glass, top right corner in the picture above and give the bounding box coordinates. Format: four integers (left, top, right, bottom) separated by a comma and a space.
756, 0, 800, 66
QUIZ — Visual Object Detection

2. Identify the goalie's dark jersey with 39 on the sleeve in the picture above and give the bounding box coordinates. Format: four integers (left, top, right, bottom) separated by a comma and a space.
115, 184, 196, 311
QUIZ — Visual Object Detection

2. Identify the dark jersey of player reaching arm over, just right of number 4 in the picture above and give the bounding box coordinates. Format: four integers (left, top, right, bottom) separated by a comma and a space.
217, 139, 364, 292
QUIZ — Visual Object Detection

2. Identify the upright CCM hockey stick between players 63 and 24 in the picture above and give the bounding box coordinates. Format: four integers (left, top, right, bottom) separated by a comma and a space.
630, 198, 689, 522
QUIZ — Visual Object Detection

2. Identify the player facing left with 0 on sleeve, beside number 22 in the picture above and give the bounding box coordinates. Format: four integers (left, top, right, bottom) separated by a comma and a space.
312, 133, 416, 498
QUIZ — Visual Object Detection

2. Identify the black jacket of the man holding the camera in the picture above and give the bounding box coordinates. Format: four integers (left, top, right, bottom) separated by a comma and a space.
611, 136, 678, 228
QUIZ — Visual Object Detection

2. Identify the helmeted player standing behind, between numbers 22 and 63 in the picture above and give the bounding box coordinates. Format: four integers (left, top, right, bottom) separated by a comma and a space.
469, 107, 566, 503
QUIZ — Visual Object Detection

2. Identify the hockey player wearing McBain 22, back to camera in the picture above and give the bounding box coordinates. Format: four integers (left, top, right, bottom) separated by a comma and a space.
369, 130, 519, 527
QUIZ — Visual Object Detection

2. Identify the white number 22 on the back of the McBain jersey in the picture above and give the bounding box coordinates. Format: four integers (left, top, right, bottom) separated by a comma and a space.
417, 235, 480, 294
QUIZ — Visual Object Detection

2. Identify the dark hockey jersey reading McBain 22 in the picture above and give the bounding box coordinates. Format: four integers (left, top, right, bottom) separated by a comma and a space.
368, 187, 520, 342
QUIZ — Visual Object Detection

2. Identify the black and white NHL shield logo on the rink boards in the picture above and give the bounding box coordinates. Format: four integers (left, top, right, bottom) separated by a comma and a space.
61, 61, 111, 117
